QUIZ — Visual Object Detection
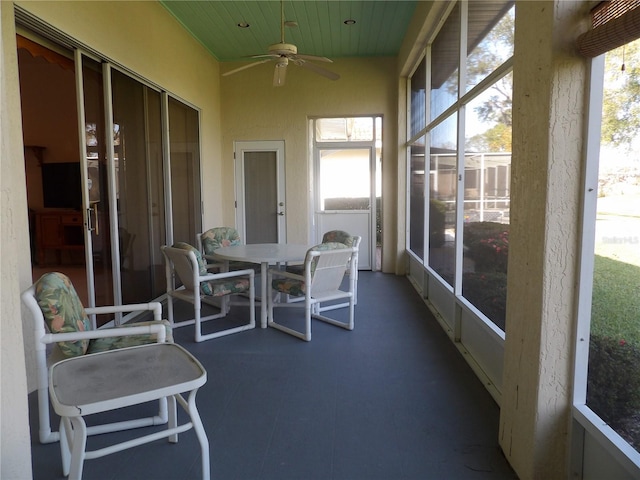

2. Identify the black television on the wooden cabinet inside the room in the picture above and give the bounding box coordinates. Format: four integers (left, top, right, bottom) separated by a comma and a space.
42, 162, 82, 210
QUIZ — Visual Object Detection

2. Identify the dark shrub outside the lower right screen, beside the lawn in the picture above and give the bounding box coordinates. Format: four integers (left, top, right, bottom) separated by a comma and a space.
587, 335, 640, 430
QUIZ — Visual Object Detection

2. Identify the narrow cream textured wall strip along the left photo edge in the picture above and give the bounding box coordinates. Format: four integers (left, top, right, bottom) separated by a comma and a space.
0, 2, 31, 480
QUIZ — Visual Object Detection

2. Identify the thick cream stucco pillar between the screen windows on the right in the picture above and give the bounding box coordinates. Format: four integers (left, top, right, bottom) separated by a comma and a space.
500, 1, 588, 479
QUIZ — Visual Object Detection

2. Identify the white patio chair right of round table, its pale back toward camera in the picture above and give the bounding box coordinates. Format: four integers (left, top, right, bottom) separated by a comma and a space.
267, 242, 357, 341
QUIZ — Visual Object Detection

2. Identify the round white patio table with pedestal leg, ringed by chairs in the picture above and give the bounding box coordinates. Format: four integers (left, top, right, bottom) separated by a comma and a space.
213, 243, 311, 328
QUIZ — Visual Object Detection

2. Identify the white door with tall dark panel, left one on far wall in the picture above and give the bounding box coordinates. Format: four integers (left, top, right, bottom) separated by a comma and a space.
234, 141, 287, 244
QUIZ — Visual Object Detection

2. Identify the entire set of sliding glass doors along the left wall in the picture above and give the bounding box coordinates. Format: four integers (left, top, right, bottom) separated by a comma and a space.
18, 32, 202, 318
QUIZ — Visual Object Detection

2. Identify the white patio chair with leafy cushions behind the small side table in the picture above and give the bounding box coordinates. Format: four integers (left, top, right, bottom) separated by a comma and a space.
21, 272, 173, 443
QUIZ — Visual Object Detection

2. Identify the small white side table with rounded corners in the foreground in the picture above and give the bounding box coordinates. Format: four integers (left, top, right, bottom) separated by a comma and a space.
49, 343, 210, 480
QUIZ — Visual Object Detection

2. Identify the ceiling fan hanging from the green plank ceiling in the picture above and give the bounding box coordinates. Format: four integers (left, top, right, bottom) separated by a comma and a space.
222, 0, 340, 87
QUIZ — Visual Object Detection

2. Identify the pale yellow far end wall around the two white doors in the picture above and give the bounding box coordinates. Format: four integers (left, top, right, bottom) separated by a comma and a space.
221, 58, 398, 271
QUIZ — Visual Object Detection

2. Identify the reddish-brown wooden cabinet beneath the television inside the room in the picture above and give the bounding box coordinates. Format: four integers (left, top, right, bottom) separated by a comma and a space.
34, 208, 84, 265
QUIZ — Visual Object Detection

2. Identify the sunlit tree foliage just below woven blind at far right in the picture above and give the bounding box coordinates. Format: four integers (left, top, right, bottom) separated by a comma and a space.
602, 40, 640, 149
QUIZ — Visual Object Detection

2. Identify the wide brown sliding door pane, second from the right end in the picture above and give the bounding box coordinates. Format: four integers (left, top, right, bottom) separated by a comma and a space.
111, 69, 166, 303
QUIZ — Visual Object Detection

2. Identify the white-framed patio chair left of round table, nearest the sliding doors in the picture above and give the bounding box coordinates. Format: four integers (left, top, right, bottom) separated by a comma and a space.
160, 242, 256, 342
